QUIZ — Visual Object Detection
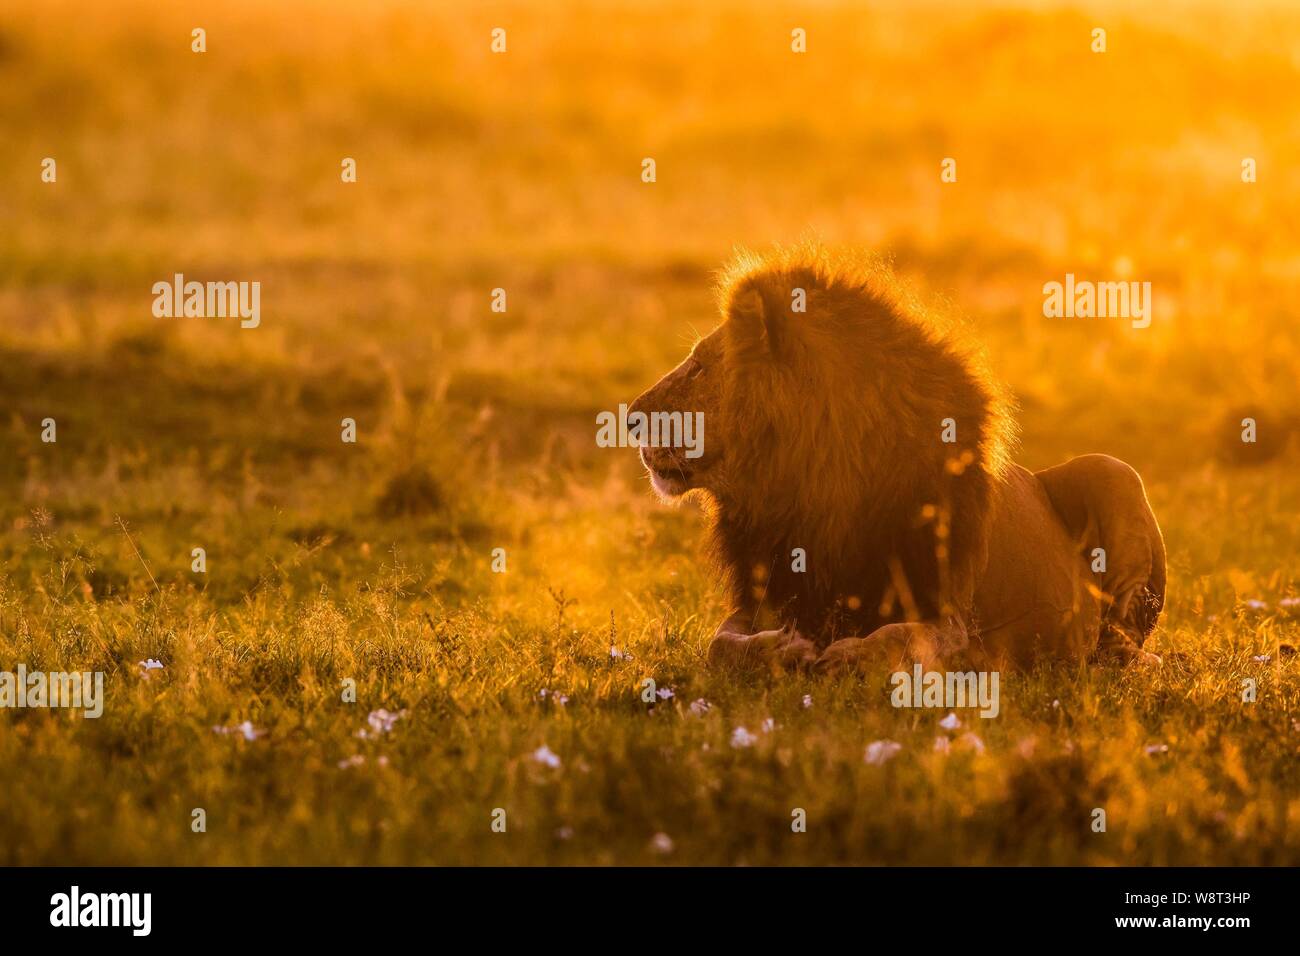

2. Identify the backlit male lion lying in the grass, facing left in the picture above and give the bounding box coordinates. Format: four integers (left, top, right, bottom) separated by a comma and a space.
629, 247, 1165, 670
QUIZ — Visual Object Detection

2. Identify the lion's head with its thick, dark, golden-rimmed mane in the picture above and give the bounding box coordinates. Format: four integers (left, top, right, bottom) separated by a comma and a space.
629, 246, 1009, 642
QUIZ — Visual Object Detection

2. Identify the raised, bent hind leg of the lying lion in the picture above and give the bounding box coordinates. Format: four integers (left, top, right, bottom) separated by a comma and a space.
1035, 455, 1165, 659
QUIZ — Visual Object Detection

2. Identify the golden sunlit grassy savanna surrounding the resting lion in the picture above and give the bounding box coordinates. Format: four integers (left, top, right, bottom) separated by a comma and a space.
0, 0, 1300, 864
